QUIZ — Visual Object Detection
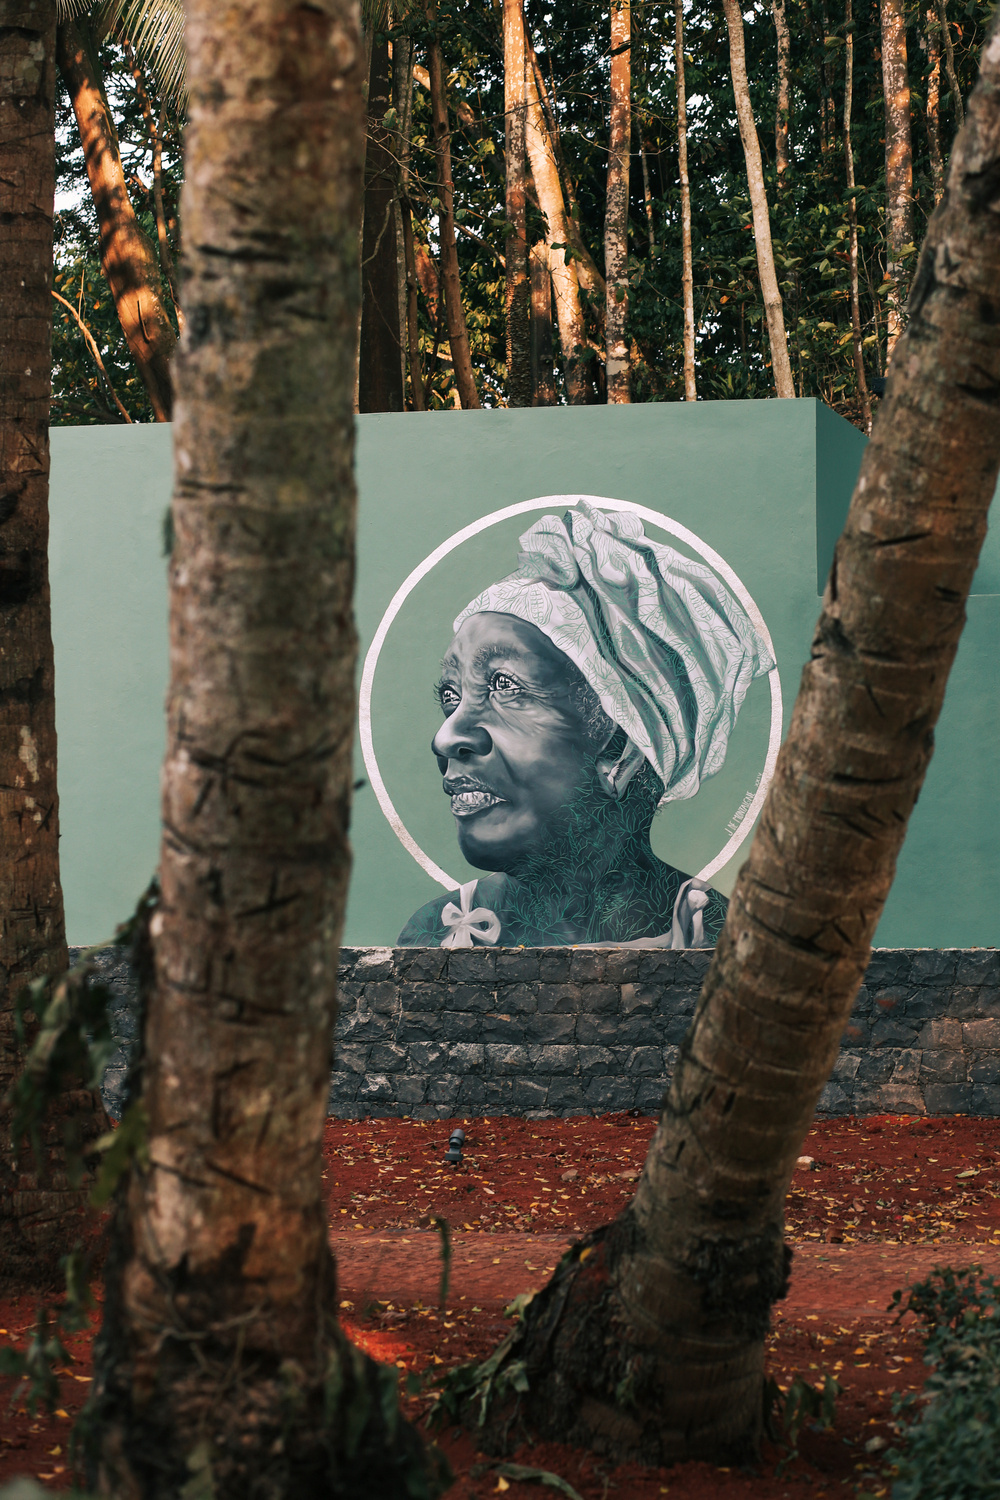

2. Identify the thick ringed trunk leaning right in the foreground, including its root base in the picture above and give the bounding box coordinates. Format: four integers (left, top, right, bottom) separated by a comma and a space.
477, 14, 1000, 1464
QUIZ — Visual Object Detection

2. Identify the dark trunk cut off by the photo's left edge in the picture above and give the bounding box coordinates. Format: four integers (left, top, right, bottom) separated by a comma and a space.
0, 0, 106, 1292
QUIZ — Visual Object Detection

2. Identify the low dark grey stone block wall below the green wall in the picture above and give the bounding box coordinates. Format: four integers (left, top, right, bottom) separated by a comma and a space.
76, 948, 1000, 1119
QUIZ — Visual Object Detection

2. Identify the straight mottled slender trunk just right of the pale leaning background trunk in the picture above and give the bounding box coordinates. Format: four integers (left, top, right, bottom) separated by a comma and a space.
604, 0, 631, 407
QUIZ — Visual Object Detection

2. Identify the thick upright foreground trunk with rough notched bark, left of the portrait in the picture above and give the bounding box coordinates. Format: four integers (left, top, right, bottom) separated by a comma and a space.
90, 0, 436, 1500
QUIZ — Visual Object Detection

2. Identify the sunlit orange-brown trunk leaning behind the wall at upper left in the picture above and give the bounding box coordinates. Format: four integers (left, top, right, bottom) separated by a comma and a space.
55, 17, 177, 422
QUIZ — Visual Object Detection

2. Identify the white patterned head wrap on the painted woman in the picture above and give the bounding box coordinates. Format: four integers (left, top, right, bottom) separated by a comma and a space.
454, 500, 774, 803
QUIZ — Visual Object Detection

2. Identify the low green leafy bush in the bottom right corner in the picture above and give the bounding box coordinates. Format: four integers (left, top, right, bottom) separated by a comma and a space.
886, 1266, 1000, 1500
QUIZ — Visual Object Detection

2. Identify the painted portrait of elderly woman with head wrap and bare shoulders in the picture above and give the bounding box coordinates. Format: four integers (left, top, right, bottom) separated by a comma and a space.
399, 498, 775, 948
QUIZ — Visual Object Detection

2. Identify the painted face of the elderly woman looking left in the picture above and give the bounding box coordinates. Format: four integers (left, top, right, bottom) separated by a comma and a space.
430, 614, 603, 870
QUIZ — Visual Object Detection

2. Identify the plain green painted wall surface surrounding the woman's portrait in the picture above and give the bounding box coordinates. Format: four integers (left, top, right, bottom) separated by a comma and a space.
51, 401, 1000, 947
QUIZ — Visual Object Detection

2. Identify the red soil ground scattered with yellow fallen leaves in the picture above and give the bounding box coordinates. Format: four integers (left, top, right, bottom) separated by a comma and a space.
0, 1116, 1000, 1500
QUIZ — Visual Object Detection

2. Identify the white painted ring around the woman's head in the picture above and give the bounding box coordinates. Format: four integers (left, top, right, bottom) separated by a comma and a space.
358, 495, 781, 891
